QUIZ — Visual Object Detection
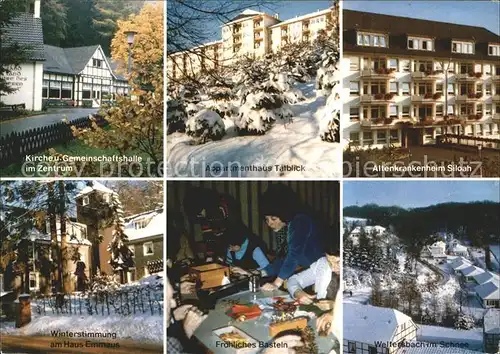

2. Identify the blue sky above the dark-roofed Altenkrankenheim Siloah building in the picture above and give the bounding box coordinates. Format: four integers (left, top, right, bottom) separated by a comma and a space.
343, 0, 500, 34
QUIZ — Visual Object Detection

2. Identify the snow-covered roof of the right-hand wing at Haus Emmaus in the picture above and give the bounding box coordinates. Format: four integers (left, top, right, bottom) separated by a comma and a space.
125, 209, 166, 241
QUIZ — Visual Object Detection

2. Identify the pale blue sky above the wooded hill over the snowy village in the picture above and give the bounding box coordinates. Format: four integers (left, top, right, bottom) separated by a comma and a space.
343, 180, 500, 208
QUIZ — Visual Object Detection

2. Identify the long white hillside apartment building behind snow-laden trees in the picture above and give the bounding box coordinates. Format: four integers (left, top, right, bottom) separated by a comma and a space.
167, 8, 335, 79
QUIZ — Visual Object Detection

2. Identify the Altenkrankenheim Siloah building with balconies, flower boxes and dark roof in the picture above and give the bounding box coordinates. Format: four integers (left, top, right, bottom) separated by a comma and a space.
341, 10, 500, 147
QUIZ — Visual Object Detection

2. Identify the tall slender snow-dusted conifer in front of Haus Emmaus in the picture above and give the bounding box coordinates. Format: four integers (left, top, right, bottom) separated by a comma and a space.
107, 192, 135, 283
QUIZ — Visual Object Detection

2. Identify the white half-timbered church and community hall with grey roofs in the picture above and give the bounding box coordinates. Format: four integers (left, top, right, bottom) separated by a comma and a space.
0, 0, 130, 111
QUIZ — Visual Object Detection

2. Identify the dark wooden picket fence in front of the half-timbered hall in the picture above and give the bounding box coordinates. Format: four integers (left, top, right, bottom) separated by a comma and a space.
0, 116, 108, 167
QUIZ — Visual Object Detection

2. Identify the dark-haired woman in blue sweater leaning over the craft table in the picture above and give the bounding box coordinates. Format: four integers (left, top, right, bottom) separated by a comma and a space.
261, 184, 325, 291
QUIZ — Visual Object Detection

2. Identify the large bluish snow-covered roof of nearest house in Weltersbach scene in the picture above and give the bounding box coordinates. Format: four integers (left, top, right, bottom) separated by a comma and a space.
344, 302, 411, 344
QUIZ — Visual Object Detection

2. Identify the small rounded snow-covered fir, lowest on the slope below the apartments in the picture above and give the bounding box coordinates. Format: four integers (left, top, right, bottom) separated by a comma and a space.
186, 109, 226, 144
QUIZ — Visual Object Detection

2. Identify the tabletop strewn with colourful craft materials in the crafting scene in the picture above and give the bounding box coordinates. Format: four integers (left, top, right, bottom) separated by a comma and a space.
194, 290, 339, 354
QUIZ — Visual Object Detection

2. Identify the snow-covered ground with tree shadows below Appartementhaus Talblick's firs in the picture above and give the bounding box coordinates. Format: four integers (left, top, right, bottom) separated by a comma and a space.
167, 83, 342, 178
